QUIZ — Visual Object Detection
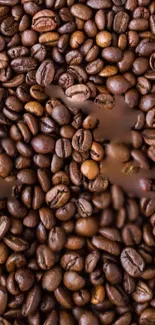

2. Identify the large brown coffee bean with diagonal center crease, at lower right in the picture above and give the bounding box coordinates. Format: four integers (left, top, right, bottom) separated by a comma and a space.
121, 247, 145, 277
